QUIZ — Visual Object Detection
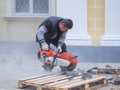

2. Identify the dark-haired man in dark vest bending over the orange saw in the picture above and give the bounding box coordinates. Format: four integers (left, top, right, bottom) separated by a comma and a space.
36, 16, 73, 53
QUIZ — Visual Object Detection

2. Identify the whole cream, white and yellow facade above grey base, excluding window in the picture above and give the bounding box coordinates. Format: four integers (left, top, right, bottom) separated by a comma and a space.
0, 0, 120, 46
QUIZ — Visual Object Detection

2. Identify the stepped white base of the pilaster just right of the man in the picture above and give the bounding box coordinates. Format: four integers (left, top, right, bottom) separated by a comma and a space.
65, 35, 92, 46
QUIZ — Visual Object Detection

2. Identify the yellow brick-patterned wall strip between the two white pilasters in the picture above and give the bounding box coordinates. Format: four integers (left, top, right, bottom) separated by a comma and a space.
87, 0, 105, 45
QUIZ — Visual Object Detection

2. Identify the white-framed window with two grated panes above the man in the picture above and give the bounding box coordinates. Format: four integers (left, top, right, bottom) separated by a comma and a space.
8, 0, 55, 17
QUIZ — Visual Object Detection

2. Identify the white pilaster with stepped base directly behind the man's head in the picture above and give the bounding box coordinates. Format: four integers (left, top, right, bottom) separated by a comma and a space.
57, 0, 92, 45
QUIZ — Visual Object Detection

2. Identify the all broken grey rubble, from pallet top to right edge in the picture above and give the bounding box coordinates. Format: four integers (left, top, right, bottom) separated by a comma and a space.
62, 65, 120, 85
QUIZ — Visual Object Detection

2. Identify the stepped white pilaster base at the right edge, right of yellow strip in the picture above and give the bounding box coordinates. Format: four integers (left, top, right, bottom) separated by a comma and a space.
101, 35, 120, 46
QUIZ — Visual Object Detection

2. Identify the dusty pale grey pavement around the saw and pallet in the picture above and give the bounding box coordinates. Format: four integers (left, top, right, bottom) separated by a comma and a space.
0, 55, 120, 90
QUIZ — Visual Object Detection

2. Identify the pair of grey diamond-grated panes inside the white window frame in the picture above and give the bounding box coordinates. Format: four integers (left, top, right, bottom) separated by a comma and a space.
15, 0, 49, 14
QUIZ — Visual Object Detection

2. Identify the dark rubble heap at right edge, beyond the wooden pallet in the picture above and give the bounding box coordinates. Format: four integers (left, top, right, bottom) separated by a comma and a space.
87, 65, 120, 85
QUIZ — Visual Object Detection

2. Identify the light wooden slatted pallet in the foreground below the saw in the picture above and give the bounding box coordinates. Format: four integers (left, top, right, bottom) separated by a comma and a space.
18, 75, 106, 90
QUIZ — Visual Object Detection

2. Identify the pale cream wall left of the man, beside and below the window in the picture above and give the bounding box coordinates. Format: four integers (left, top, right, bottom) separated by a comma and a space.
0, 0, 43, 41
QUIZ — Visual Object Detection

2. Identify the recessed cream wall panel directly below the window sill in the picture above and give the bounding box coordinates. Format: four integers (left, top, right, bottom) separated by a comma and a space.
8, 20, 41, 41
